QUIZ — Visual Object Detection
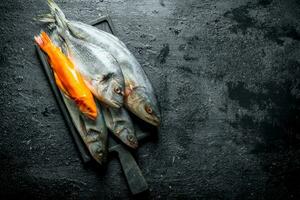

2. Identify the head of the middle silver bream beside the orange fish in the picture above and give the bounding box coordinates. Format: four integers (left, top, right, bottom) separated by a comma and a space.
95, 73, 124, 108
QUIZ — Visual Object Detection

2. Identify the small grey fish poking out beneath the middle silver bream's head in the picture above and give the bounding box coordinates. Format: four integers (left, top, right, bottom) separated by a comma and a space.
102, 107, 138, 149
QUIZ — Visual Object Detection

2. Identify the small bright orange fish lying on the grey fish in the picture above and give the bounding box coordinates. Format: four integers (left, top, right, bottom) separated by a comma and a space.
34, 32, 97, 119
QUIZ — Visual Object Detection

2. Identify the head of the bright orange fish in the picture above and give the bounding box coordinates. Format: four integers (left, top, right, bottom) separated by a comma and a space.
75, 97, 98, 120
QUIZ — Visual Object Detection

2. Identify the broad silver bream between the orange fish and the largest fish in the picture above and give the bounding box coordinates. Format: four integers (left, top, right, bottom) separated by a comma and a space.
62, 31, 125, 108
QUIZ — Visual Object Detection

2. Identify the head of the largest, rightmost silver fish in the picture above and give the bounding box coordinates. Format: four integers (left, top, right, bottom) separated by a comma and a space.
126, 87, 160, 126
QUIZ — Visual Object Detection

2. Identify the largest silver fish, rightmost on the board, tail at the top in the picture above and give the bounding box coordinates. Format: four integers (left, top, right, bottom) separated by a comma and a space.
40, 0, 160, 126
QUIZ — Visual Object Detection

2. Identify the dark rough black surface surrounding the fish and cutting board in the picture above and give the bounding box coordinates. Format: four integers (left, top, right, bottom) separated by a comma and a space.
0, 0, 300, 200
